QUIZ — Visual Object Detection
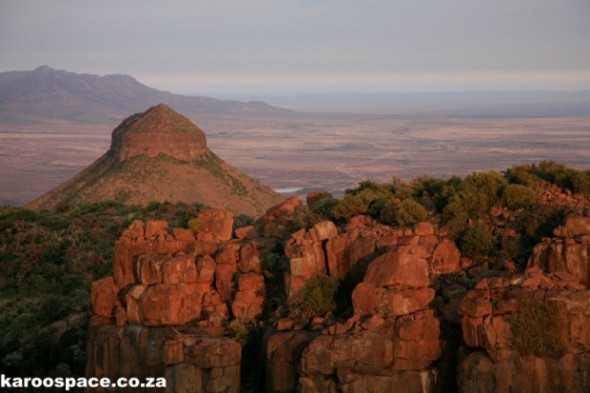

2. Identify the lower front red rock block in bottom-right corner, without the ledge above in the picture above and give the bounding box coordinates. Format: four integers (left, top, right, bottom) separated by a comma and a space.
458, 269, 590, 393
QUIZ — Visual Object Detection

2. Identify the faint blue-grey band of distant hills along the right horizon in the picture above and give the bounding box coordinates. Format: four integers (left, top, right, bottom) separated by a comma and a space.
256, 90, 590, 118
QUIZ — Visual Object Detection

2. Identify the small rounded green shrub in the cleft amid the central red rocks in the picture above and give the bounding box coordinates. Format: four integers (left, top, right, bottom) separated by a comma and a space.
288, 276, 339, 324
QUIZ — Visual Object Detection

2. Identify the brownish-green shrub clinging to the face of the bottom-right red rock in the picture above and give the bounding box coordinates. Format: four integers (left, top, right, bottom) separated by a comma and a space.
506, 300, 564, 356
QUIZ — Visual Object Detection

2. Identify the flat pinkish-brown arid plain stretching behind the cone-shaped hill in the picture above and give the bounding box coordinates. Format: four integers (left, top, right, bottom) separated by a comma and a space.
0, 113, 590, 205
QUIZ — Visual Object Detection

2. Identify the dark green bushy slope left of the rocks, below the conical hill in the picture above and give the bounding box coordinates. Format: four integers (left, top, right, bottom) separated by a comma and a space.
0, 201, 206, 377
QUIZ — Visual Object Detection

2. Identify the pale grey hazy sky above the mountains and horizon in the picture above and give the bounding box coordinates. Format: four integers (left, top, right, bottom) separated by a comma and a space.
0, 0, 590, 94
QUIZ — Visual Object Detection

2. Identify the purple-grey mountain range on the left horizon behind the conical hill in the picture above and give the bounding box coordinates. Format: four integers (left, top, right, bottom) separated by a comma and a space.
0, 66, 291, 124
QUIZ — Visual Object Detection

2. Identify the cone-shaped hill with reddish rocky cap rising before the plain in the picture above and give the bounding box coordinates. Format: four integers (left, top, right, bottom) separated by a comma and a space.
28, 104, 281, 216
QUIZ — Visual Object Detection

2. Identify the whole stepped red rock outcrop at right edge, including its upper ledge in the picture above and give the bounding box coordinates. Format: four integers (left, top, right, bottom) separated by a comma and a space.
459, 216, 590, 392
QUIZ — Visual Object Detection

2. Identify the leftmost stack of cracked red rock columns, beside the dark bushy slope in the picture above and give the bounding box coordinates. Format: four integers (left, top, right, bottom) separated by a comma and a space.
87, 210, 269, 392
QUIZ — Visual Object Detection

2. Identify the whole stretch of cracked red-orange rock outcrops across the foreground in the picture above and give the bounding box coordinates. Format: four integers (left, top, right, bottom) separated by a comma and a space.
86, 198, 590, 393
